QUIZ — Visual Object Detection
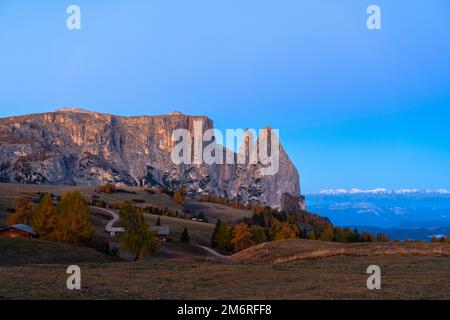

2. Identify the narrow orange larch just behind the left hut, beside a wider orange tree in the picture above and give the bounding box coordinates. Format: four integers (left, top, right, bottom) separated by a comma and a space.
32, 193, 58, 240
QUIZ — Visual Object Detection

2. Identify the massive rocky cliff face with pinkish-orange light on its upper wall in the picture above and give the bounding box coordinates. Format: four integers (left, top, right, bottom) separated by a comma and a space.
0, 109, 300, 208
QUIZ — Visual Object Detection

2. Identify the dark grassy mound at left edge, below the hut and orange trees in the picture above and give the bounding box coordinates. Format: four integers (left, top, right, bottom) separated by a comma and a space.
0, 238, 116, 266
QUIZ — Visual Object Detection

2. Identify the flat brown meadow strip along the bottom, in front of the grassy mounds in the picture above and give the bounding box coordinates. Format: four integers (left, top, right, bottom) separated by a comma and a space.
0, 252, 450, 299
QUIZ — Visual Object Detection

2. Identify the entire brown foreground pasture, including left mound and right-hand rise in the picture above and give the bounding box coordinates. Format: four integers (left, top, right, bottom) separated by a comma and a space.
0, 239, 450, 299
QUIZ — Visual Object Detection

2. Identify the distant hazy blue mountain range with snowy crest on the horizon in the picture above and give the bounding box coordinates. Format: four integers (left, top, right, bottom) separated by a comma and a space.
306, 188, 450, 240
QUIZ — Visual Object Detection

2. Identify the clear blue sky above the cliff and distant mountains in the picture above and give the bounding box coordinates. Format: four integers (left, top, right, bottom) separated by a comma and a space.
0, 0, 450, 192
